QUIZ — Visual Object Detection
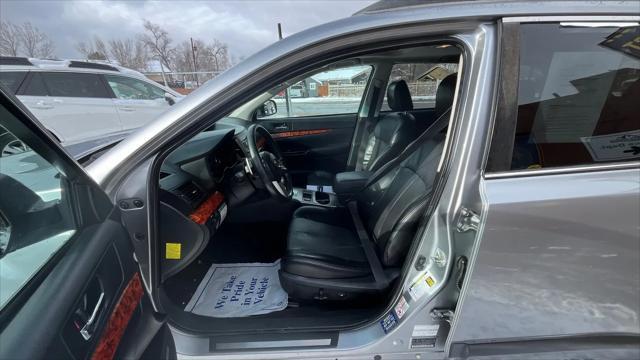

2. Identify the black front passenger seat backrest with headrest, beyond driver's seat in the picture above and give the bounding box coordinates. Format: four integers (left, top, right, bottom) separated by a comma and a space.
362, 80, 417, 171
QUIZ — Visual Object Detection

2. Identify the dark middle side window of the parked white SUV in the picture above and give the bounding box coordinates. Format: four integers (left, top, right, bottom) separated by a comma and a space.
42, 72, 111, 98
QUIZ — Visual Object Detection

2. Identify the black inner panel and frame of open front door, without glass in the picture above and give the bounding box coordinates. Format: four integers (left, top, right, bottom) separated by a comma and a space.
0, 91, 175, 359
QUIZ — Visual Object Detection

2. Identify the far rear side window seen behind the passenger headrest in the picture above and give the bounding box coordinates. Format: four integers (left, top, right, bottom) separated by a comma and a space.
381, 63, 458, 111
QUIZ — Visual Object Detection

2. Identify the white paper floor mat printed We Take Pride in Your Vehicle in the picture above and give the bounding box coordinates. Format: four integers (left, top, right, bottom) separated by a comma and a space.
184, 260, 288, 317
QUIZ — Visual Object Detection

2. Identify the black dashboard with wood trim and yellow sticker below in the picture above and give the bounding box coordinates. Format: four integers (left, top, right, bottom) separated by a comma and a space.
158, 119, 255, 280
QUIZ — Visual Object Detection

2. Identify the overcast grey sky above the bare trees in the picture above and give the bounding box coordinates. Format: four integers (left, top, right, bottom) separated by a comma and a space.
0, 0, 373, 59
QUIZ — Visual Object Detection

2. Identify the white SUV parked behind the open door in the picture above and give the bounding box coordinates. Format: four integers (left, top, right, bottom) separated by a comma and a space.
0, 57, 183, 153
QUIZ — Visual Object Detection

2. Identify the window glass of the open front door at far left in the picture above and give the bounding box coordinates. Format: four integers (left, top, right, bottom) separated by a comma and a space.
0, 124, 75, 309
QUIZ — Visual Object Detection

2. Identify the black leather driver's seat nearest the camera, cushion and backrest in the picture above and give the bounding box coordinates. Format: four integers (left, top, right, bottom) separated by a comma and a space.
280, 134, 444, 300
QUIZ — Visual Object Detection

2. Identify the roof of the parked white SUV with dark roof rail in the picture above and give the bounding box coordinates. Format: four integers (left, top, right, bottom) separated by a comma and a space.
0, 56, 146, 78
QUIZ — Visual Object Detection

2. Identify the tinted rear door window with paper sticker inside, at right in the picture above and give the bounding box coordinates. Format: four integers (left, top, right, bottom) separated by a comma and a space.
511, 24, 640, 169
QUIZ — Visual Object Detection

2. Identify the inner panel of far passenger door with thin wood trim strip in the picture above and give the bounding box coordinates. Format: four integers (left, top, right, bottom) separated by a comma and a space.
260, 114, 357, 184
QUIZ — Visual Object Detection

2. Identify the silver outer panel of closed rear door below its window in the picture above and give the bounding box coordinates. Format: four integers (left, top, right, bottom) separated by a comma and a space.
452, 169, 640, 342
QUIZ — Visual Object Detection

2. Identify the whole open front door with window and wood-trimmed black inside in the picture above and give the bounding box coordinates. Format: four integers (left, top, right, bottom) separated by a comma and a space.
0, 87, 176, 359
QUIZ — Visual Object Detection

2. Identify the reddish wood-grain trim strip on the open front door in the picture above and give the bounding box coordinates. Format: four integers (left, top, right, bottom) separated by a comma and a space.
91, 272, 144, 360
